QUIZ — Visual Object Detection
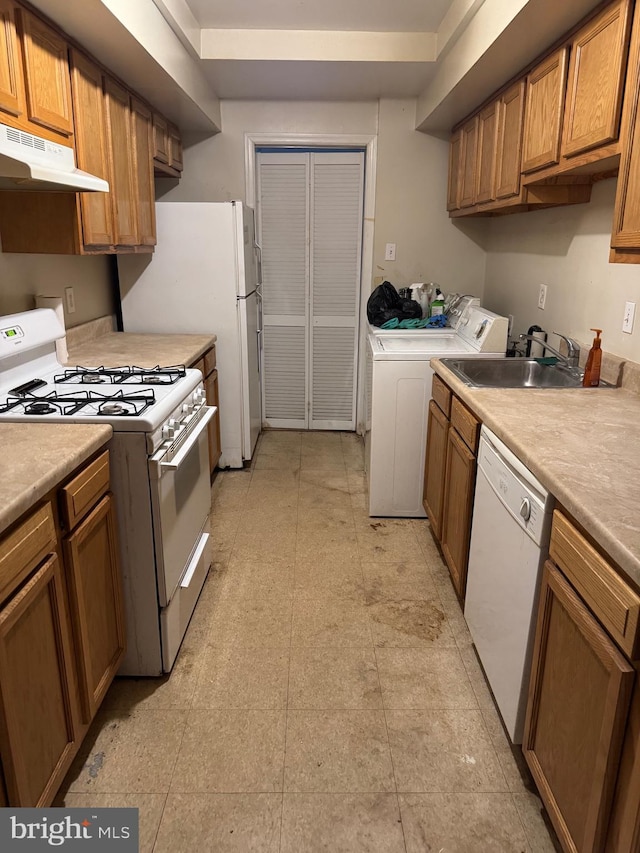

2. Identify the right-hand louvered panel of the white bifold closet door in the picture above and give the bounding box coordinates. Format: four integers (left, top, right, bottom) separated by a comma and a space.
309, 151, 364, 430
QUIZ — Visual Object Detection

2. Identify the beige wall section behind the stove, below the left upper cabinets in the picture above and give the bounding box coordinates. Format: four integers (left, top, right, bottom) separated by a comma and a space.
0, 243, 114, 328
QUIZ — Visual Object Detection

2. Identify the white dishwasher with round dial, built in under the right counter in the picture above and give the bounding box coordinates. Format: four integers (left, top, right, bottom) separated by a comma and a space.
464, 426, 553, 743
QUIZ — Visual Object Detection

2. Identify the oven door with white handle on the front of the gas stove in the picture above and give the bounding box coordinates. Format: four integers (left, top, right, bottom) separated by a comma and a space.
149, 406, 216, 607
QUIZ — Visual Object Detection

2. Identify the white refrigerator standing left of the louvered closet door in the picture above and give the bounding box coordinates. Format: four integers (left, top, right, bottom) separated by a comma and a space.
118, 201, 262, 468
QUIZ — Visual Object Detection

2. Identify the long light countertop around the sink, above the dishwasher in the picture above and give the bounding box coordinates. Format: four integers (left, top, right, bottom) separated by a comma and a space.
431, 359, 640, 588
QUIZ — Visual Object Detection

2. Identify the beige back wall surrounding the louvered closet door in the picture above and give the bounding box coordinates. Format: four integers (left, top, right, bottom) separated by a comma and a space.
156, 100, 486, 295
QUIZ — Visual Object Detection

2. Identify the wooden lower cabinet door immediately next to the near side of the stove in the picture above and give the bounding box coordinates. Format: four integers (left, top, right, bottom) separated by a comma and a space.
64, 495, 125, 723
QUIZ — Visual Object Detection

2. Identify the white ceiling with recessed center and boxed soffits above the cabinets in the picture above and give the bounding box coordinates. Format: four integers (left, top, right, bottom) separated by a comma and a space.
26, 0, 600, 138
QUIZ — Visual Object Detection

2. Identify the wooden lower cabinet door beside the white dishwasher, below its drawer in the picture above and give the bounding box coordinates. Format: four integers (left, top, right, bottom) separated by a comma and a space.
522, 561, 634, 853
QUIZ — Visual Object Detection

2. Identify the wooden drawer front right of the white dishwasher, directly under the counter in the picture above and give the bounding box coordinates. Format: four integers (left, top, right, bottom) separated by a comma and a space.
549, 510, 640, 659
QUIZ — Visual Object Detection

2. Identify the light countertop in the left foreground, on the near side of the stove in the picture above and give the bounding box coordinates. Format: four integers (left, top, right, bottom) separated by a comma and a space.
0, 422, 113, 532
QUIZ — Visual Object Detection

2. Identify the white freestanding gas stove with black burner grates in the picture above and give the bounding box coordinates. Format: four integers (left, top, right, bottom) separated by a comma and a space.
0, 308, 216, 675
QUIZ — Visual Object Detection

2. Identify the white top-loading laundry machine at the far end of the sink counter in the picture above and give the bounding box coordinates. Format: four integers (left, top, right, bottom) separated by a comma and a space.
365, 297, 508, 518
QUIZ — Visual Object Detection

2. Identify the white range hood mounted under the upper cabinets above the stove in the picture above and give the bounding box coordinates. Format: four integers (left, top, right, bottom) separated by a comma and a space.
0, 124, 109, 193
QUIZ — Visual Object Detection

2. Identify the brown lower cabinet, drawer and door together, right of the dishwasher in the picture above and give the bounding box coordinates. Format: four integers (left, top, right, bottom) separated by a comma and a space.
522, 510, 640, 853
